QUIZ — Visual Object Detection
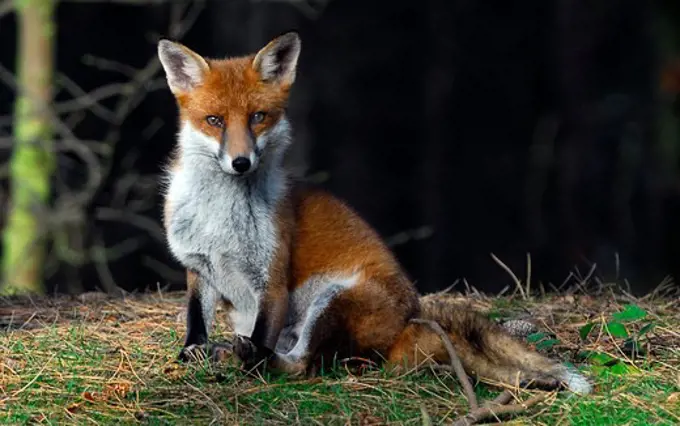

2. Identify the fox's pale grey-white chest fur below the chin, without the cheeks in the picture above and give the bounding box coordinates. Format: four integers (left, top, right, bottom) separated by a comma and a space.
166, 155, 278, 335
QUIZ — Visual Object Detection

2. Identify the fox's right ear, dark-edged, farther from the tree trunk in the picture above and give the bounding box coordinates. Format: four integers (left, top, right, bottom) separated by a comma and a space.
253, 31, 302, 85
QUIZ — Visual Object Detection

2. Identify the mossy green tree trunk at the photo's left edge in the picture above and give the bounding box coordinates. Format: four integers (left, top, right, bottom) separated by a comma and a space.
0, 0, 55, 294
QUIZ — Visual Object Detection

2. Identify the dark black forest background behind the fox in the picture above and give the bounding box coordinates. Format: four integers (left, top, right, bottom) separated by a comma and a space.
0, 0, 680, 293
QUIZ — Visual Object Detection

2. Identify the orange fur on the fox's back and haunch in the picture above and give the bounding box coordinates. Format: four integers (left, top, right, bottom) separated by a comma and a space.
282, 190, 418, 353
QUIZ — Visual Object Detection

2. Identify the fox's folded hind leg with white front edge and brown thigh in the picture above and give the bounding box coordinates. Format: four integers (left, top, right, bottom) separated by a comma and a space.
234, 276, 418, 375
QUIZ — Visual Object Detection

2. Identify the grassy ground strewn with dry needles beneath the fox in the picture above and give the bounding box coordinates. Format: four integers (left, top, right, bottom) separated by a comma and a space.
0, 284, 680, 425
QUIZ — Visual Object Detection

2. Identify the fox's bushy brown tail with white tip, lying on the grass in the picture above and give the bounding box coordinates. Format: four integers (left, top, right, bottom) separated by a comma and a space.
389, 294, 592, 394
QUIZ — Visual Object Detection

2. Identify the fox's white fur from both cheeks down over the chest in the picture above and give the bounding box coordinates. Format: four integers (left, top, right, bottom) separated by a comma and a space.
165, 117, 290, 336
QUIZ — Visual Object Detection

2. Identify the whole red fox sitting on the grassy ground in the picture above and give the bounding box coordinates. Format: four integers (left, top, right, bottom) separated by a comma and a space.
158, 32, 591, 393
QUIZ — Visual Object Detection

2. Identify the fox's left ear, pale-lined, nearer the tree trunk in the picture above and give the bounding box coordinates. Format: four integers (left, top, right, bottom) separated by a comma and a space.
158, 40, 209, 94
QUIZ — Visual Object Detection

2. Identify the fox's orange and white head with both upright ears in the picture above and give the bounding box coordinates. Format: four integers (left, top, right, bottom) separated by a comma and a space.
158, 32, 301, 175
